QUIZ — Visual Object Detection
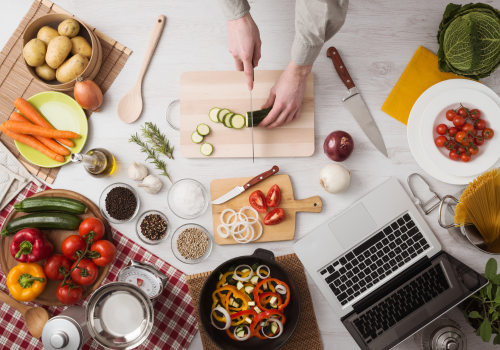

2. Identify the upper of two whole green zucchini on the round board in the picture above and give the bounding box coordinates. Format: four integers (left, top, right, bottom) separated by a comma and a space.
14, 197, 87, 214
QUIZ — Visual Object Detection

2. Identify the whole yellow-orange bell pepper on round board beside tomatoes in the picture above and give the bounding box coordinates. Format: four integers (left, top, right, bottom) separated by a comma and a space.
7, 263, 47, 301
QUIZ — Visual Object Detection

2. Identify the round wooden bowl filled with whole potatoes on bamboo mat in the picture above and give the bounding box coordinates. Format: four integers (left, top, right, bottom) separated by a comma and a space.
23, 14, 102, 91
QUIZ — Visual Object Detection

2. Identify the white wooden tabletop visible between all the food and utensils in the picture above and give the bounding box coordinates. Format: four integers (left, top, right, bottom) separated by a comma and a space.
0, 0, 500, 350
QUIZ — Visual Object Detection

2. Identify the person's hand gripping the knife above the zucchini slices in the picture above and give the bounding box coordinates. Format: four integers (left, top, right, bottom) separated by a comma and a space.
227, 13, 262, 90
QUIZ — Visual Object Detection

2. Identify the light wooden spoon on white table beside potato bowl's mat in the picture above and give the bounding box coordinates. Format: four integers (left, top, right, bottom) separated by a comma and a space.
117, 15, 167, 123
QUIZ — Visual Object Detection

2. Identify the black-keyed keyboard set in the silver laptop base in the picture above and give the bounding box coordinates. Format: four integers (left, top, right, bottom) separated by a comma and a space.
320, 214, 430, 305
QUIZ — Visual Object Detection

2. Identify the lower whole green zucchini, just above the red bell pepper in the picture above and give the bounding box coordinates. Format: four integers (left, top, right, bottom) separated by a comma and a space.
0, 213, 82, 237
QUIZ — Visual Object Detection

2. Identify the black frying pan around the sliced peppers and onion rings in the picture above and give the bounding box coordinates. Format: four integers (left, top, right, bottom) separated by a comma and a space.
198, 248, 300, 350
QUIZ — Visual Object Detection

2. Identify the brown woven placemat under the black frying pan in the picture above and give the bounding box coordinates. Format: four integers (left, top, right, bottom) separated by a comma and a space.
187, 254, 322, 350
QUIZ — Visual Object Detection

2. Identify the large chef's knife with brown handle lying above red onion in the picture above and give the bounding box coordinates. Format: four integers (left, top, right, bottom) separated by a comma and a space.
326, 47, 389, 158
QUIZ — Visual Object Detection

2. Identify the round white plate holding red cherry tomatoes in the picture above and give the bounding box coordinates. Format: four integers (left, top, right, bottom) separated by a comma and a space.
420, 89, 500, 176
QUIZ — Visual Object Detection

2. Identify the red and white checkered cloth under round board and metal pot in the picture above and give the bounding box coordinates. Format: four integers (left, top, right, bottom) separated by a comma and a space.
0, 183, 198, 350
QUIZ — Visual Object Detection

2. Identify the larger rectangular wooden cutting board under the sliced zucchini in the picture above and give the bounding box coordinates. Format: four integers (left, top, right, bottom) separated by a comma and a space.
180, 69, 314, 158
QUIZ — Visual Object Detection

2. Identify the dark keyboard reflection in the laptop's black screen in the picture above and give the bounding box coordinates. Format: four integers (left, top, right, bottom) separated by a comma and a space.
353, 264, 450, 343
